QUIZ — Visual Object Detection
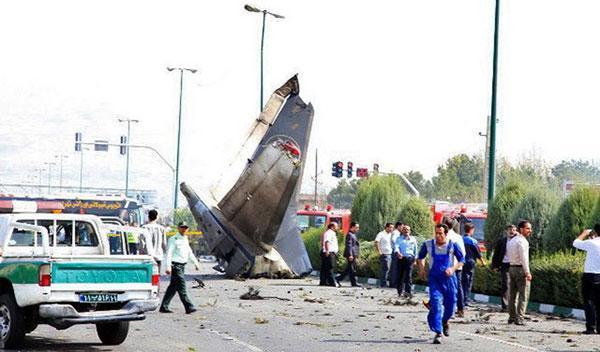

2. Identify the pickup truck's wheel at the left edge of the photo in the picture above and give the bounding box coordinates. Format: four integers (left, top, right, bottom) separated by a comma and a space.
0, 293, 25, 348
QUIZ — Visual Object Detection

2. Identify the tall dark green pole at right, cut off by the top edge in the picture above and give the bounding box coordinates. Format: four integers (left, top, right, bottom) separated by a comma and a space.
488, 0, 500, 204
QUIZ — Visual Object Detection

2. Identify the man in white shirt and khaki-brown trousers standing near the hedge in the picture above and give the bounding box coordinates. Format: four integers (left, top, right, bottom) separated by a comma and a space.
506, 220, 532, 325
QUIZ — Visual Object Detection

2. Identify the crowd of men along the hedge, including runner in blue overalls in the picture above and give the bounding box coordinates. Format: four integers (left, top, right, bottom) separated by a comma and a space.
320, 217, 600, 343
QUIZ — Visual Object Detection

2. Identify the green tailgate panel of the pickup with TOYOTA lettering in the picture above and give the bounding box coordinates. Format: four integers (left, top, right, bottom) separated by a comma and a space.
52, 262, 152, 284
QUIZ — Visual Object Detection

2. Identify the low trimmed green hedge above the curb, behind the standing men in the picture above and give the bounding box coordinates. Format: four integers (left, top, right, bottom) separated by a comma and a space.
302, 229, 585, 308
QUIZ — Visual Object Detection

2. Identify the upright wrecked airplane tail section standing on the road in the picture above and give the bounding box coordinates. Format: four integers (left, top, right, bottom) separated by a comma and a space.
181, 76, 314, 278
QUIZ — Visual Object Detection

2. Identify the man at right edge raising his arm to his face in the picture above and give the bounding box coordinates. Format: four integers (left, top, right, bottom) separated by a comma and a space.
573, 224, 600, 334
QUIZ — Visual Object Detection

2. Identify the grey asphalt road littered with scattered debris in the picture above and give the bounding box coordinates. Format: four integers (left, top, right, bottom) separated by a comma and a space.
12, 263, 600, 352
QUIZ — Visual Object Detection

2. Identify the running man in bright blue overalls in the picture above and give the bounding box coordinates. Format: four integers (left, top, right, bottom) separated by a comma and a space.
418, 224, 465, 344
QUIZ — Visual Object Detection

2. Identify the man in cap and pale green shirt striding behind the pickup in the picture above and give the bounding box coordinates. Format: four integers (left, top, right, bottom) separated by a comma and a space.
159, 222, 200, 314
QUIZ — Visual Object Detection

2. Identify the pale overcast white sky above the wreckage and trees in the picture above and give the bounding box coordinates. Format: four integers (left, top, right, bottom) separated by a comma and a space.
0, 0, 600, 208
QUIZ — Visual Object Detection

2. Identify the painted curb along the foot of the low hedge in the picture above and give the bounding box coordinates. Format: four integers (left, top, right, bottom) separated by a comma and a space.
311, 270, 585, 320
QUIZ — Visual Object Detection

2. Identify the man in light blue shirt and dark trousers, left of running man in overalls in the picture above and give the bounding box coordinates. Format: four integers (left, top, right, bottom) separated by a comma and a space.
394, 225, 417, 298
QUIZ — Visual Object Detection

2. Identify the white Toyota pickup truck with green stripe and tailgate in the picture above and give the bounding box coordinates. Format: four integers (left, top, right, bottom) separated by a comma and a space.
0, 213, 159, 348
